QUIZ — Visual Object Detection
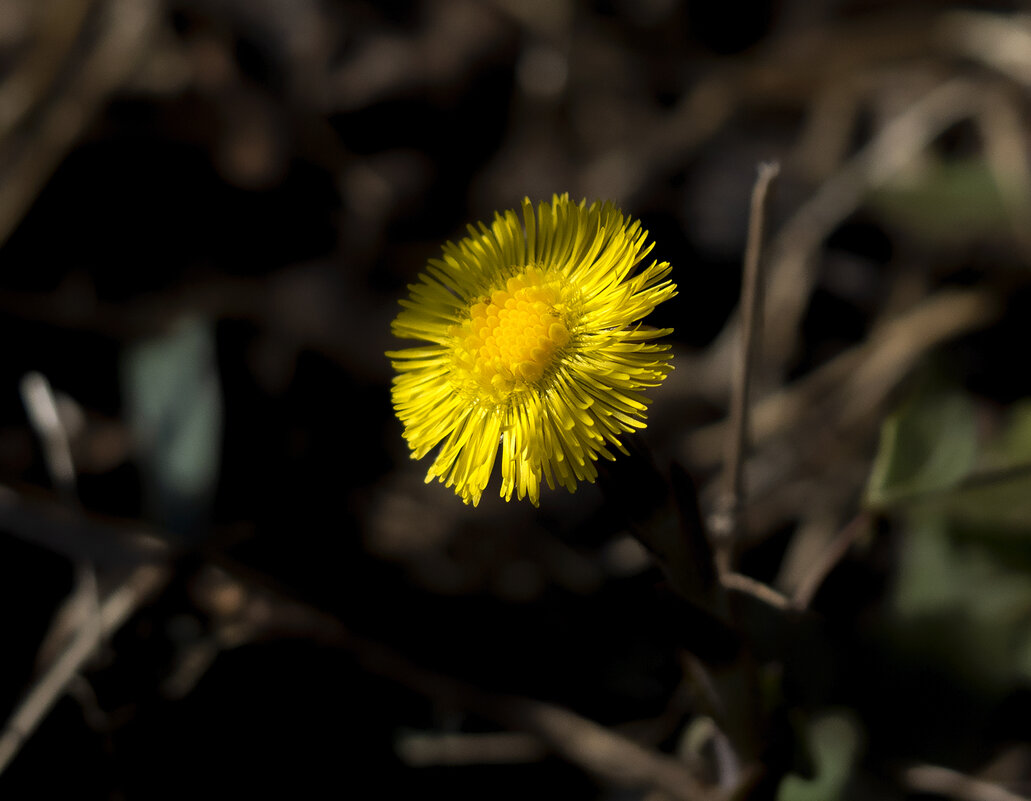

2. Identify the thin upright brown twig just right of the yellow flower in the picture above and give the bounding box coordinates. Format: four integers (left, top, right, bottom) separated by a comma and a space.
710, 162, 780, 574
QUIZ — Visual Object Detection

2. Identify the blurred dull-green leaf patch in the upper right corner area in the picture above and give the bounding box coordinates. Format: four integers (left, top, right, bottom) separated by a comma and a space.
869, 159, 1009, 242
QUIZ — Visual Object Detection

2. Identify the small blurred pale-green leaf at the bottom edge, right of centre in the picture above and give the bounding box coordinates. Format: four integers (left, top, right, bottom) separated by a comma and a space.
776, 711, 861, 801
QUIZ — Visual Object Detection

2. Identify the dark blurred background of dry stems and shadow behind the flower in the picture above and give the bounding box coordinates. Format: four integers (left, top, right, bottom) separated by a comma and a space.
6, 0, 1031, 801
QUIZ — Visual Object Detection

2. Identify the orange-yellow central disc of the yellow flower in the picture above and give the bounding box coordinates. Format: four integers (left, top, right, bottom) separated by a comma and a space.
455, 268, 569, 401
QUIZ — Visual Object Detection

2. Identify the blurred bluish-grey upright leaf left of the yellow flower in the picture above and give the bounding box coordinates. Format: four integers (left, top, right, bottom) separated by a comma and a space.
122, 320, 223, 538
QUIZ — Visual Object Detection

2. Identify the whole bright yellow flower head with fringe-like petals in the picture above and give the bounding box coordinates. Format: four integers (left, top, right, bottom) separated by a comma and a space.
387, 195, 676, 505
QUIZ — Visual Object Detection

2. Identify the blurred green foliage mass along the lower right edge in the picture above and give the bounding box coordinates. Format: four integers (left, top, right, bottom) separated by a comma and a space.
867, 379, 1031, 695
